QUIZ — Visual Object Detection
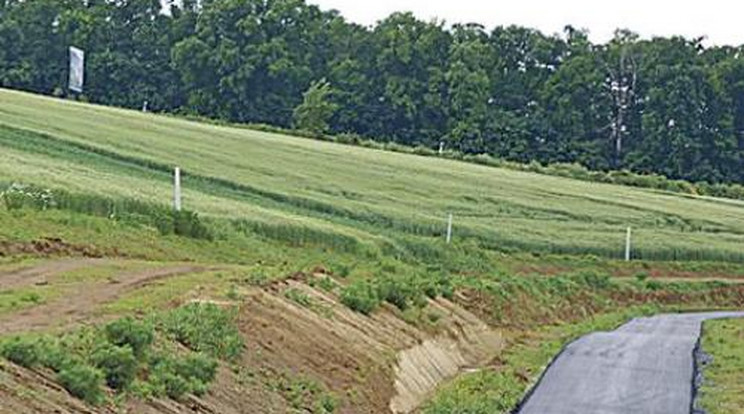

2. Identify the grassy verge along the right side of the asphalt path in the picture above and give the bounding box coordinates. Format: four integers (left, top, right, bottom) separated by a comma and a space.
698, 319, 744, 414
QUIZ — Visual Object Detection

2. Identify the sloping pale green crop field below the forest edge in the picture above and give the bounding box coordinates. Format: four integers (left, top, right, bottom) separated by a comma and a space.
0, 90, 744, 261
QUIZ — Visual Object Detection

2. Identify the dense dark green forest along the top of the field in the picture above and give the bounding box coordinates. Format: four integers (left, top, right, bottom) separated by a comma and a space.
0, 0, 744, 183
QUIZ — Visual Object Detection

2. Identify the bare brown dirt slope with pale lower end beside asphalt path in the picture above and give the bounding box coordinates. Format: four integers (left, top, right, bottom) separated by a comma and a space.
241, 281, 503, 413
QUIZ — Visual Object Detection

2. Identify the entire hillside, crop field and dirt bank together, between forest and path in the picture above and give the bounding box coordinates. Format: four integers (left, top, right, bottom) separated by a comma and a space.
0, 90, 744, 414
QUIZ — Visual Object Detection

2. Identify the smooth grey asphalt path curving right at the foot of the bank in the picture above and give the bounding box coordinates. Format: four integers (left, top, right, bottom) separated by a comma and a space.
518, 312, 744, 414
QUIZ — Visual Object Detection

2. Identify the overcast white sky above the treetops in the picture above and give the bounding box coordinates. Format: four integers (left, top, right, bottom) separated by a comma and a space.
308, 0, 744, 45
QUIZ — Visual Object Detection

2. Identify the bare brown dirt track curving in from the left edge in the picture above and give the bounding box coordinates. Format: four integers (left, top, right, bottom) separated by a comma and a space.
0, 265, 208, 335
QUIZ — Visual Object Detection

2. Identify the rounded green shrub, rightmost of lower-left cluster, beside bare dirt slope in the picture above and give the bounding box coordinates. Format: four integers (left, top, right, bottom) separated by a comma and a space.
160, 303, 243, 360
